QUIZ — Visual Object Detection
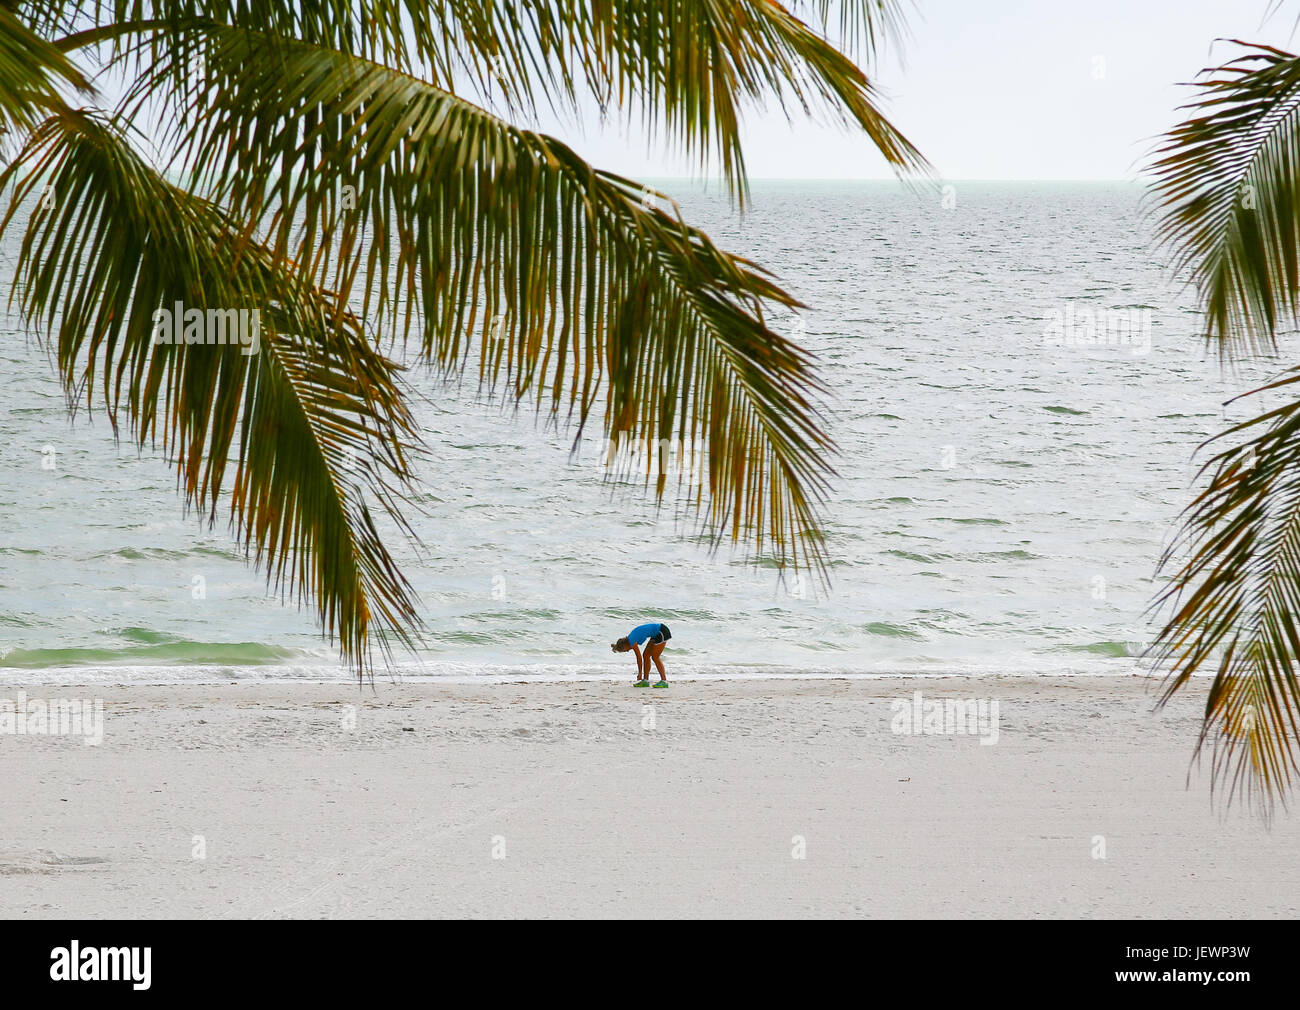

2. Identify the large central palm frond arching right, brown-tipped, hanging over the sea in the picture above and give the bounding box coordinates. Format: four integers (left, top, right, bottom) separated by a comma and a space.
124, 29, 832, 565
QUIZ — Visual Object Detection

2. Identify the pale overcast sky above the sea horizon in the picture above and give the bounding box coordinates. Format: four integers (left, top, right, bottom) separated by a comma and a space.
525, 0, 1300, 179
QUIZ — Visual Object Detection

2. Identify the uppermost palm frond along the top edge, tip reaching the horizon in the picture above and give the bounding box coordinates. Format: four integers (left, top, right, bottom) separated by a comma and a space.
73, 0, 928, 198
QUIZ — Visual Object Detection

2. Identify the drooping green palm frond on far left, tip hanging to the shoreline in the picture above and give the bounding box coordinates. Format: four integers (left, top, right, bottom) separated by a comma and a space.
0, 109, 420, 671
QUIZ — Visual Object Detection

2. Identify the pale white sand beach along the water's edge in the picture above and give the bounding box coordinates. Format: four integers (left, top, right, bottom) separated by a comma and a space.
0, 677, 1300, 918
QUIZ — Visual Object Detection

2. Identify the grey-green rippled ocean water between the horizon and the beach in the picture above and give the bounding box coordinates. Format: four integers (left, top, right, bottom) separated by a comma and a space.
0, 181, 1279, 684
